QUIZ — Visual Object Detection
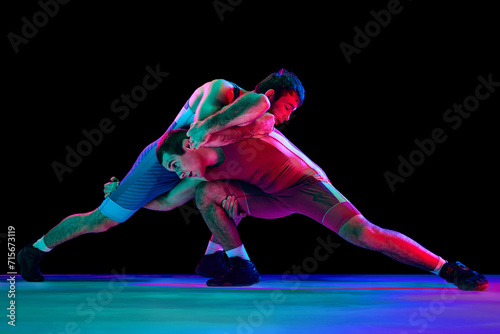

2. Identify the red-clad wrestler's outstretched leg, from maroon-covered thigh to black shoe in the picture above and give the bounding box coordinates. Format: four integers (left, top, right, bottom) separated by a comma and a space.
286, 182, 488, 290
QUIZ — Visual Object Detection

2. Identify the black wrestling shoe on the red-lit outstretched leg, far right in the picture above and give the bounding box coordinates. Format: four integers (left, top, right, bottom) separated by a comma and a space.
439, 261, 489, 291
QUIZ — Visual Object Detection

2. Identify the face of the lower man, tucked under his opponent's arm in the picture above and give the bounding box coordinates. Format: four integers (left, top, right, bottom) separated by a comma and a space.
163, 139, 207, 179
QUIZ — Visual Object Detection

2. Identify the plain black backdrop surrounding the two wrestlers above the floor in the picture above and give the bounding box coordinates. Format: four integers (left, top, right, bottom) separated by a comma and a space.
4, 0, 500, 274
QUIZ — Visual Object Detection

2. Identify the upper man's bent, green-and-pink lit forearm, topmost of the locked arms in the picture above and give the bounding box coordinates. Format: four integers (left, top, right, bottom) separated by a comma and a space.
203, 92, 270, 134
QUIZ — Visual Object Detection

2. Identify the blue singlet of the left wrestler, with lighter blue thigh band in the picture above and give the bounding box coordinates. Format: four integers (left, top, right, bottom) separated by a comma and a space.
99, 100, 194, 223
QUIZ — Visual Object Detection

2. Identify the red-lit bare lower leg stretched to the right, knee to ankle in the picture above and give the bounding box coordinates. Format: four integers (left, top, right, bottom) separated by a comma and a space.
339, 215, 439, 271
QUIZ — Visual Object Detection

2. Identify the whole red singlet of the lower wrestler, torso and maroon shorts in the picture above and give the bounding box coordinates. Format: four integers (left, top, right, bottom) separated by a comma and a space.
204, 130, 359, 232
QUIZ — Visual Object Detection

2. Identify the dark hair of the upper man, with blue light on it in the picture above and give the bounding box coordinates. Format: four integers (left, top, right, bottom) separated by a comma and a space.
255, 68, 306, 107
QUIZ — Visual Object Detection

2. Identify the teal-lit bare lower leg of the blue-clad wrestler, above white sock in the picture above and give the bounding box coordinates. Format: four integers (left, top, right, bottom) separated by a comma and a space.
44, 209, 119, 248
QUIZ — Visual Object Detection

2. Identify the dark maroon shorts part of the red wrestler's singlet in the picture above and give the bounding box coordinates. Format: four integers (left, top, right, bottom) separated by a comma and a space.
217, 178, 360, 233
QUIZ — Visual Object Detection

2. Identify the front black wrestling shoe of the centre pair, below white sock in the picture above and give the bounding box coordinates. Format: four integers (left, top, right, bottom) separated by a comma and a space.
207, 256, 260, 286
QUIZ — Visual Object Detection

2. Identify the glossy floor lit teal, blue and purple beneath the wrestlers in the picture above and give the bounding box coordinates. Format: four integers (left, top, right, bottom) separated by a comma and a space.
4, 271, 500, 334
